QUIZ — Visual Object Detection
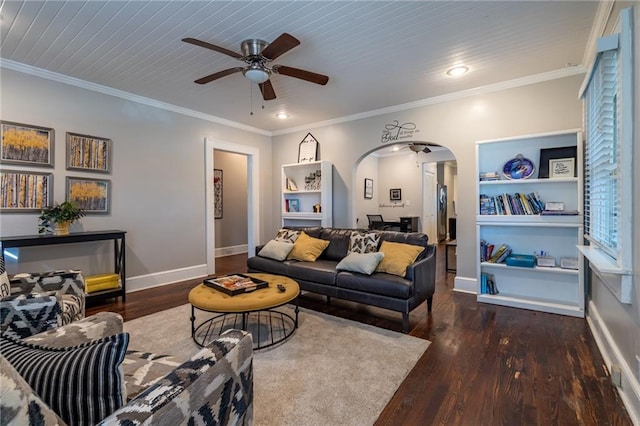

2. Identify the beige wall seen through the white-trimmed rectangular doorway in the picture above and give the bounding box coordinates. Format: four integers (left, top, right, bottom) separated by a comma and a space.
214, 150, 248, 252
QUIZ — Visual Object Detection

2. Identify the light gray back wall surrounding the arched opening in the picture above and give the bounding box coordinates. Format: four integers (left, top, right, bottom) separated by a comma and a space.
271, 76, 583, 280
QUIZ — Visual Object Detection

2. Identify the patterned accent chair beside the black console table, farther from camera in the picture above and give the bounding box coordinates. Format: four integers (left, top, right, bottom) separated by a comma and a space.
0, 270, 85, 337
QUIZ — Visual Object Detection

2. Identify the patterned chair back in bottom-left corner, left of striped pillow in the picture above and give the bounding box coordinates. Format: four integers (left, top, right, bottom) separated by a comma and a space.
0, 356, 63, 425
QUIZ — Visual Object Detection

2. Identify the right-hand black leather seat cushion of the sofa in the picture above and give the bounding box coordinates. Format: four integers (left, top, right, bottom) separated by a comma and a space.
336, 272, 412, 299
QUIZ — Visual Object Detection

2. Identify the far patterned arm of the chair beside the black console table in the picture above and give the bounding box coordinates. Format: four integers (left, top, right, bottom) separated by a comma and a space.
10, 270, 85, 324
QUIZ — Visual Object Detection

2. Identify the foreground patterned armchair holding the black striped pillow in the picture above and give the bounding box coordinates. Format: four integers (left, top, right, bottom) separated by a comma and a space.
0, 312, 253, 426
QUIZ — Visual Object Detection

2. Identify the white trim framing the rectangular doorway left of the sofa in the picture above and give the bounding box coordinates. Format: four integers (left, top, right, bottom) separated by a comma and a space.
204, 138, 260, 275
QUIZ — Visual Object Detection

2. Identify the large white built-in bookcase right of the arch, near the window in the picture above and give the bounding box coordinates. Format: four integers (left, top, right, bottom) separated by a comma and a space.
476, 129, 585, 317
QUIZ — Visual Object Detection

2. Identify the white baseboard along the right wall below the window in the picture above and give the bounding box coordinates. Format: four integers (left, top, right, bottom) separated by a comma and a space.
587, 302, 640, 425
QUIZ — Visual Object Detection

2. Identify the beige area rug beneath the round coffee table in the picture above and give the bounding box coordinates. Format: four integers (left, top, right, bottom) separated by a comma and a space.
124, 304, 430, 426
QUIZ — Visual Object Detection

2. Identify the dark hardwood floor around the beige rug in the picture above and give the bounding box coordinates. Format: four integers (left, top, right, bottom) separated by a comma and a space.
87, 245, 631, 426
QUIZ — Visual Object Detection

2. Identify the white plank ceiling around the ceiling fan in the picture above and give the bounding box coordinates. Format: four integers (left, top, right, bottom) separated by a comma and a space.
0, 1, 598, 132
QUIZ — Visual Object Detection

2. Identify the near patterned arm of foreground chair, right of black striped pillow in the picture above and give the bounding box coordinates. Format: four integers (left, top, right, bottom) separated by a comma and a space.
100, 330, 253, 425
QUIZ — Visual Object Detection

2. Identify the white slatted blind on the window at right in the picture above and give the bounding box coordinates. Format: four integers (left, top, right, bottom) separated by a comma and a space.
584, 50, 621, 259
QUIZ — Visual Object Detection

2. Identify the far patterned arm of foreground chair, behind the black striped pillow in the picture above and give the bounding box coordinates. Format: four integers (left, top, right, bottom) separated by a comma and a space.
23, 312, 123, 348
